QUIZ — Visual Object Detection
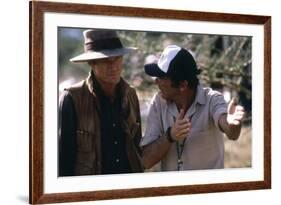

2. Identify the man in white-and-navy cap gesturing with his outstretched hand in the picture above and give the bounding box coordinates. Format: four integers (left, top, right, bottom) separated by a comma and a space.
140, 45, 244, 171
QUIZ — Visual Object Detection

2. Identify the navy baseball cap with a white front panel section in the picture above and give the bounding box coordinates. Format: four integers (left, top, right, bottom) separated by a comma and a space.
144, 45, 201, 80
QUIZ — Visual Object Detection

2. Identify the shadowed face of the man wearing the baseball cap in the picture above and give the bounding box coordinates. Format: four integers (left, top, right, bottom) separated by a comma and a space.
155, 77, 179, 101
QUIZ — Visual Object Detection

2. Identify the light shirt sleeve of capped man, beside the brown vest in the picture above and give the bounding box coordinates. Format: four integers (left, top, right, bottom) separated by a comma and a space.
140, 95, 163, 146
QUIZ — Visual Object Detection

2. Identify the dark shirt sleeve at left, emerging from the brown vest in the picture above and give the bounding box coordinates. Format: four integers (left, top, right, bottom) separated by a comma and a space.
58, 91, 76, 176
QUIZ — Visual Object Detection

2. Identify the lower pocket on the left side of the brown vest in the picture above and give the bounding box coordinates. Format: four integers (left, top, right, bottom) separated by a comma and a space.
76, 130, 94, 152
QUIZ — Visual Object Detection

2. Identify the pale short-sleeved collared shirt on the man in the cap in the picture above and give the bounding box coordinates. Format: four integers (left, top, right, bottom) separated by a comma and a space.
140, 85, 227, 171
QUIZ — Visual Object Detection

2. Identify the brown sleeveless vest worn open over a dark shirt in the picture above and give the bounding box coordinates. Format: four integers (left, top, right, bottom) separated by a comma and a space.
67, 74, 144, 175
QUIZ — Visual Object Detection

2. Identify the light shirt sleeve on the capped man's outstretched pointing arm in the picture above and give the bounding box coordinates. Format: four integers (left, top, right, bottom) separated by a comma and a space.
210, 93, 227, 129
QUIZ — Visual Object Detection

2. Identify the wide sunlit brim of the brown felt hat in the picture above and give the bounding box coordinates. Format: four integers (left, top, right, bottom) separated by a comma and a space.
70, 47, 137, 63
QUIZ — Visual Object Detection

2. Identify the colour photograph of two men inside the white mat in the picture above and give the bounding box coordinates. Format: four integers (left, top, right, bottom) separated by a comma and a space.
58, 27, 252, 176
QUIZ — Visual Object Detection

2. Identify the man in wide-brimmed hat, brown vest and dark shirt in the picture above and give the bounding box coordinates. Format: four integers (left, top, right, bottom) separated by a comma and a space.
59, 29, 143, 176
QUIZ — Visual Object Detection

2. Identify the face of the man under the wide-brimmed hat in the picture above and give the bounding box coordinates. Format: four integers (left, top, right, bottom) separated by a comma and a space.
90, 56, 123, 85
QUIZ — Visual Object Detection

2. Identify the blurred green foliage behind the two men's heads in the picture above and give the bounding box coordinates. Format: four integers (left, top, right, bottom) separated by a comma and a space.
58, 27, 252, 117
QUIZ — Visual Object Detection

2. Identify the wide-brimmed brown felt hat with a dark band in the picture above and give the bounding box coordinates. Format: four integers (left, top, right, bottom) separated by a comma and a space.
70, 29, 137, 63
